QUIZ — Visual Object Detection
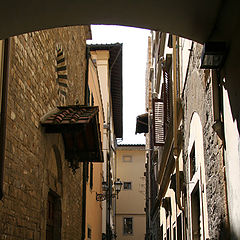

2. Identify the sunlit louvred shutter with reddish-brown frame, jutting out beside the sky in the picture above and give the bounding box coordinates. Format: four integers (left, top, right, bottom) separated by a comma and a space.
153, 99, 165, 146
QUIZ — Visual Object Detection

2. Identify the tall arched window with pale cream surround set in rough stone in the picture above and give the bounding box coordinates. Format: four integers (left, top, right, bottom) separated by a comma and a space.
188, 113, 208, 240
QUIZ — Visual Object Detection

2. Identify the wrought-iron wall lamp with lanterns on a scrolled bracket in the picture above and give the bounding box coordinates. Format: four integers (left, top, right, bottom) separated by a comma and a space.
96, 178, 123, 202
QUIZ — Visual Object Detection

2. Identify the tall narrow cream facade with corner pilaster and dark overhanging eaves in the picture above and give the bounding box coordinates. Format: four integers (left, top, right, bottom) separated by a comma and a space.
88, 43, 123, 240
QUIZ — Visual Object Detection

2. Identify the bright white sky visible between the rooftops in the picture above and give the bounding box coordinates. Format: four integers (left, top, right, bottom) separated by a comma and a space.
87, 25, 150, 144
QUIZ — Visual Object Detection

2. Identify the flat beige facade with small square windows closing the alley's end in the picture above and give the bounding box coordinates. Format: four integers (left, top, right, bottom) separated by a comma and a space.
115, 144, 146, 240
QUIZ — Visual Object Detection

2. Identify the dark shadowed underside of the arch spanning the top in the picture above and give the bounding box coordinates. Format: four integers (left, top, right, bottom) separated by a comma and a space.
0, 0, 239, 42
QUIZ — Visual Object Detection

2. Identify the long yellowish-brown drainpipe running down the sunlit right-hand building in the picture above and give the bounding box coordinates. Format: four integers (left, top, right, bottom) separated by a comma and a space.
172, 35, 184, 211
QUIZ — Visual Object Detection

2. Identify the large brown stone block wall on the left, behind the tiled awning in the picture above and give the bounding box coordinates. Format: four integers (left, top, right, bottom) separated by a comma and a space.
0, 26, 89, 240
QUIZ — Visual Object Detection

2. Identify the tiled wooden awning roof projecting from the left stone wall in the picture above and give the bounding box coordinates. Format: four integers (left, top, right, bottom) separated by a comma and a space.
41, 105, 103, 171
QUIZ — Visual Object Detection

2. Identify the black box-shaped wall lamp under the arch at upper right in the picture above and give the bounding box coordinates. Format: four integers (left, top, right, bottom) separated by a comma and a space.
200, 42, 226, 69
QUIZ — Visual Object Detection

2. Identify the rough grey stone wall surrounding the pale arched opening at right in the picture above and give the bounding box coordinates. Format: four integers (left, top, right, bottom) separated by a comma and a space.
183, 43, 227, 239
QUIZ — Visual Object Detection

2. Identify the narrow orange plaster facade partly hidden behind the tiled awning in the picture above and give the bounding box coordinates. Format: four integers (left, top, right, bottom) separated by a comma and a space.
85, 50, 104, 239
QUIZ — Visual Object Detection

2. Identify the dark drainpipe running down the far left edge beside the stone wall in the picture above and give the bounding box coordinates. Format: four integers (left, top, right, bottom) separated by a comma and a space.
0, 39, 10, 199
